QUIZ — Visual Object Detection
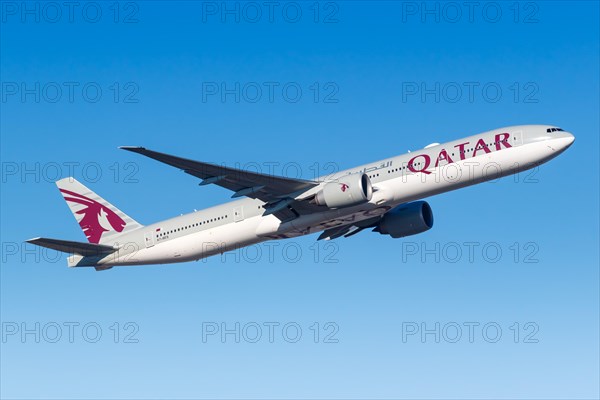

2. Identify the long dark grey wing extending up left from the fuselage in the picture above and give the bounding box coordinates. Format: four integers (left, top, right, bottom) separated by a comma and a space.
120, 146, 319, 220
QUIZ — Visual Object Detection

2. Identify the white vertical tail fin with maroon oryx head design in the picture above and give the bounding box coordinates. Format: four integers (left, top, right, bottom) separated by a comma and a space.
56, 178, 143, 243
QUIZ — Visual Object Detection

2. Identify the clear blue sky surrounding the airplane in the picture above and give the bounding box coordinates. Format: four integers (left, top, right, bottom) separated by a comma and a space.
0, 1, 600, 398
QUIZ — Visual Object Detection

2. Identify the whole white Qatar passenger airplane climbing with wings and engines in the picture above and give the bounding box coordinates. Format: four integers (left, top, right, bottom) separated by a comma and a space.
27, 125, 575, 271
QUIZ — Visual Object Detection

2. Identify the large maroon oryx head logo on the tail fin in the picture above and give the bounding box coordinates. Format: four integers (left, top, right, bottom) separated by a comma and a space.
60, 189, 125, 243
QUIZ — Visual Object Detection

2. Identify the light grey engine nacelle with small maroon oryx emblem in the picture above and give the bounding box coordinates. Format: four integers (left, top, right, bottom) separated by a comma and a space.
315, 173, 373, 208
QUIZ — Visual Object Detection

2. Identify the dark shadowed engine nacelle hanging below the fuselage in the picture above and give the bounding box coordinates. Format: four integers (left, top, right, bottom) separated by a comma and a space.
373, 201, 433, 238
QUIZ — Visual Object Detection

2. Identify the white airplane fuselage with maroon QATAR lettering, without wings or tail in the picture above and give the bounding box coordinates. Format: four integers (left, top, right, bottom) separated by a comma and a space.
69, 125, 574, 266
